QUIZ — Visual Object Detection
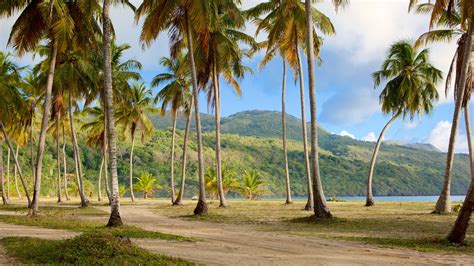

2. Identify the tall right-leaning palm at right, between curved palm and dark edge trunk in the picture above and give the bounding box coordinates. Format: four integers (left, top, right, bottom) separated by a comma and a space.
410, 1, 474, 214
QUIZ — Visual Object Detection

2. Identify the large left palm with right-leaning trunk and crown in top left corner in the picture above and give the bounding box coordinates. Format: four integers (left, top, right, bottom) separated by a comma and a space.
0, 0, 98, 216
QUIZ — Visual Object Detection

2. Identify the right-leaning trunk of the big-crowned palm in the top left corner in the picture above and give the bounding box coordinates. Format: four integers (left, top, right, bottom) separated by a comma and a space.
30, 39, 58, 216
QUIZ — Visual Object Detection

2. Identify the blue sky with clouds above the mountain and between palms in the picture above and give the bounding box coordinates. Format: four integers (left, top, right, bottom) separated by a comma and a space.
0, 0, 472, 153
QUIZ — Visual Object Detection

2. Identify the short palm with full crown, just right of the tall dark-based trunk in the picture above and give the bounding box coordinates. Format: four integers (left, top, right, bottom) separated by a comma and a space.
117, 83, 155, 201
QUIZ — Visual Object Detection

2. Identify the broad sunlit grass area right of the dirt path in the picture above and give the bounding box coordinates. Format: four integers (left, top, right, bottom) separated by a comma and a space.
155, 200, 474, 255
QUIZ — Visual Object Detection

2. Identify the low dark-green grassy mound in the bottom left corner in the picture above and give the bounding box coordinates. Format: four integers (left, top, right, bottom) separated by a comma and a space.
0, 232, 194, 265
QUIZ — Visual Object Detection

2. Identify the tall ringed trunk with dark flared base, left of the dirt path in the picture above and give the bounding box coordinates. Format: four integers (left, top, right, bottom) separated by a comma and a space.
102, 0, 123, 226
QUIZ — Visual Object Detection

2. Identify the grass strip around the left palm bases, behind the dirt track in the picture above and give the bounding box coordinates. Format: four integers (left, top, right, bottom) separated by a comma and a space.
0, 205, 194, 241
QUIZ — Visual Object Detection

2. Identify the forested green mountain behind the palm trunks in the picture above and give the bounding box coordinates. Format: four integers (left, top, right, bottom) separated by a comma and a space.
10, 111, 470, 196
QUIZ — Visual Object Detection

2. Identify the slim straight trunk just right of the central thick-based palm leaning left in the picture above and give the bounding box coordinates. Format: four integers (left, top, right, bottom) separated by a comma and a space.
212, 60, 227, 208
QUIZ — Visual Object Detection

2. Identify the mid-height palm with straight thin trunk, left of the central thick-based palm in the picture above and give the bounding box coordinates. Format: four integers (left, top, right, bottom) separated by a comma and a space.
151, 54, 191, 204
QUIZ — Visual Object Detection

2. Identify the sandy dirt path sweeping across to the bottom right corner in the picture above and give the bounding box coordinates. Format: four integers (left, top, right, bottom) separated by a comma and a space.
90, 205, 474, 265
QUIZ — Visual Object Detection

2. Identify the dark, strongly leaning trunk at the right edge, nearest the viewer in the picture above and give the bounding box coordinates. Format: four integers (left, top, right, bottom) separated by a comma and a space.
448, 103, 474, 244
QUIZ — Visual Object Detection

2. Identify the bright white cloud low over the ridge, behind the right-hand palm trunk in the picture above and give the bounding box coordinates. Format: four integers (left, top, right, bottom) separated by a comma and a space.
426, 121, 468, 153
